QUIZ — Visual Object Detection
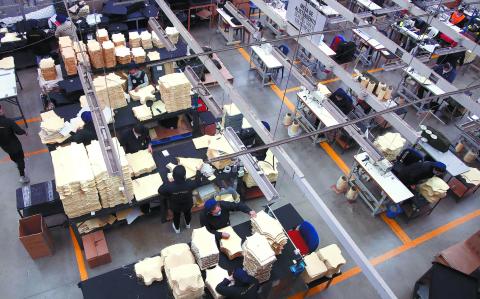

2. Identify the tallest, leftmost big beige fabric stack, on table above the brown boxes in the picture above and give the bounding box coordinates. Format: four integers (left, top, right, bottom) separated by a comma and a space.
50, 143, 102, 218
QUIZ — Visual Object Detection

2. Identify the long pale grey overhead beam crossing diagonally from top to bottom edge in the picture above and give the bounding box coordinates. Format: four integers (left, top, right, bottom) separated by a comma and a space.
156, 0, 396, 298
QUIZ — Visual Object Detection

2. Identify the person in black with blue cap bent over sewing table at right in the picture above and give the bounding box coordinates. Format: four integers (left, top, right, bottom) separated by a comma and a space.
392, 161, 447, 189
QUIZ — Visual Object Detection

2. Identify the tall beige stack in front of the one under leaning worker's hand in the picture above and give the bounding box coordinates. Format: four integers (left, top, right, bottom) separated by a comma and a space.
242, 233, 277, 283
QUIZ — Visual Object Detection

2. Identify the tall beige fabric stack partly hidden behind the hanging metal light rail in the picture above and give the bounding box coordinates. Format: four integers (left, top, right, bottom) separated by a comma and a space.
87, 138, 133, 208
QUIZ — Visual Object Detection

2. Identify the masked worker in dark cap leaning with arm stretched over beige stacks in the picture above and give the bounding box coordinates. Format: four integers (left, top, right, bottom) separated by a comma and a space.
200, 199, 257, 241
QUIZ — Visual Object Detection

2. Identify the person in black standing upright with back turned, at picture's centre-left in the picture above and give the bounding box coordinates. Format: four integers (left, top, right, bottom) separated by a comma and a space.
158, 165, 203, 234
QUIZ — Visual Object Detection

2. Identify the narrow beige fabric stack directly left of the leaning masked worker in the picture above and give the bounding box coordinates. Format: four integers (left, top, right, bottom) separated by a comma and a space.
191, 226, 219, 270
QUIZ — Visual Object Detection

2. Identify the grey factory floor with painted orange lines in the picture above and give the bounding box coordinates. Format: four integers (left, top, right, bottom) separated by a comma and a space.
0, 22, 480, 299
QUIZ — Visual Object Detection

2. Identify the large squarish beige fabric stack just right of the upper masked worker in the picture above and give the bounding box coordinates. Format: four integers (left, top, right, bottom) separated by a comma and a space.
158, 73, 192, 112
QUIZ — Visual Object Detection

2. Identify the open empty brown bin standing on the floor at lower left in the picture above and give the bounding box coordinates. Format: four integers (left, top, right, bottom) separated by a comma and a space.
18, 214, 54, 259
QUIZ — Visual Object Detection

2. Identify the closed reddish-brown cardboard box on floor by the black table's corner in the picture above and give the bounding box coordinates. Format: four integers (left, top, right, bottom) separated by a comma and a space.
82, 230, 112, 268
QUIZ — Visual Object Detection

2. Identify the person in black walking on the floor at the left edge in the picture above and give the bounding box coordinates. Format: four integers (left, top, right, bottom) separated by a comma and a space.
0, 105, 30, 184
